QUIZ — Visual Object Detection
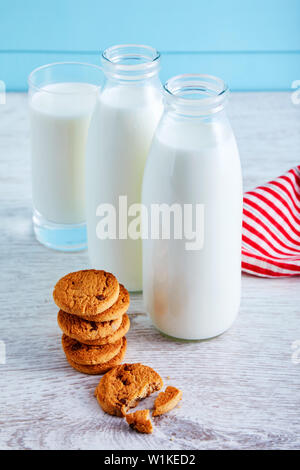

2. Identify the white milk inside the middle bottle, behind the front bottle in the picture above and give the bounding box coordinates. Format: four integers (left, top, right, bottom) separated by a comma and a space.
87, 85, 163, 291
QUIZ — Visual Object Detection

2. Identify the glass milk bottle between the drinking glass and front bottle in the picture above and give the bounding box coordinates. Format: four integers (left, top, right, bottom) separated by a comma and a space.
86, 45, 163, 291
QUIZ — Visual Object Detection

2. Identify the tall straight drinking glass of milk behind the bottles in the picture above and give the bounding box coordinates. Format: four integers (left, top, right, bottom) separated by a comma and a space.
29, 62, 103, 251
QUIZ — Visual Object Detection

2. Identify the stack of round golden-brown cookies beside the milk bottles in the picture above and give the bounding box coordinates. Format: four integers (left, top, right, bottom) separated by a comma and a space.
53, 269, 130, 375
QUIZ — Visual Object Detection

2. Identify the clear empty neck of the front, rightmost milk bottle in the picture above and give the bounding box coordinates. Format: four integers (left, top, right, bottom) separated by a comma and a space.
164, 74, 229, 119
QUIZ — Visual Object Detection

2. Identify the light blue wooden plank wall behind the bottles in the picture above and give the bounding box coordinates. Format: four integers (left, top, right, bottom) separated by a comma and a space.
0, 0, 300, 91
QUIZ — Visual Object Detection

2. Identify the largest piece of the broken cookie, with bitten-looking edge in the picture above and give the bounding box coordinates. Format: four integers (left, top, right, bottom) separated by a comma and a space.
95, 364, 163, 416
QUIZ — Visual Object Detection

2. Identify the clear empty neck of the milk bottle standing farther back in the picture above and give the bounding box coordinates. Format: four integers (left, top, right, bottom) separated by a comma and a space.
102, 44, 160, 84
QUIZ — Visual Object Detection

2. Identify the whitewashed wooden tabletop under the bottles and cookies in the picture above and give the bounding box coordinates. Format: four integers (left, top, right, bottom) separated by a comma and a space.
0, 93, 300, 449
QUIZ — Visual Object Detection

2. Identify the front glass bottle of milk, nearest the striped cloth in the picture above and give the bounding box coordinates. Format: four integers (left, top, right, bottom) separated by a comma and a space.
142, 74, 242, 340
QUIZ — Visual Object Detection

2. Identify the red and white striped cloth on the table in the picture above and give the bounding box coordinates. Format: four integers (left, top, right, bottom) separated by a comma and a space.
242, 165, 300, 277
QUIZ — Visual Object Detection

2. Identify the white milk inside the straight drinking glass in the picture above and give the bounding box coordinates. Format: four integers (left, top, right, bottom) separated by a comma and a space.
30, 83, 97, 224
